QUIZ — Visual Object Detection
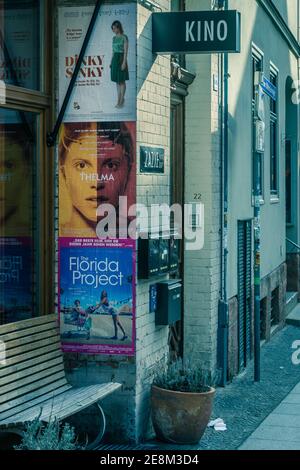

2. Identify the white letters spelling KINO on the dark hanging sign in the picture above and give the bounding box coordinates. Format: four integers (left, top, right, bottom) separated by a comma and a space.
185, 20, 228, 42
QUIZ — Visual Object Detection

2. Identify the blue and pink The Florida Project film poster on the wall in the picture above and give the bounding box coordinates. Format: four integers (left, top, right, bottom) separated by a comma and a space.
59, 238, 135, 355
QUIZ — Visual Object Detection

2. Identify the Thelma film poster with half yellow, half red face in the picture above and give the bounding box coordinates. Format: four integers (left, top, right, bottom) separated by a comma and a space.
59, 121, 136, 237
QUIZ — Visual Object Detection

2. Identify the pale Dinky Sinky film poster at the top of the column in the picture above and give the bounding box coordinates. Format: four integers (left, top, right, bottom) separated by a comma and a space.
59, 3, 136, 122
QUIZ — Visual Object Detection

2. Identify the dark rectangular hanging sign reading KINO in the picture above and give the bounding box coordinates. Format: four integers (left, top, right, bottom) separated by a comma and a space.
152, 10, 241, 54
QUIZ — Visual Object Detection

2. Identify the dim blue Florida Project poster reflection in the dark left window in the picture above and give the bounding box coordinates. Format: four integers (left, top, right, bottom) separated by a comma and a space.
0, 237, 33, 324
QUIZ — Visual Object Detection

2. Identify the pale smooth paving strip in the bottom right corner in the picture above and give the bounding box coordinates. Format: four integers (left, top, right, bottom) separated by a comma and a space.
239, 383, 300, 450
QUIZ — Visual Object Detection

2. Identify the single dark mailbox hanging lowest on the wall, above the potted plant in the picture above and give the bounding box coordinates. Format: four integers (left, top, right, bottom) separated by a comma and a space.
155, 279, 182, 326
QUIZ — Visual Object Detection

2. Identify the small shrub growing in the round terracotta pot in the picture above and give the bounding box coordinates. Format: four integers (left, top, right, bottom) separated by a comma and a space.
153, 359, 217, 393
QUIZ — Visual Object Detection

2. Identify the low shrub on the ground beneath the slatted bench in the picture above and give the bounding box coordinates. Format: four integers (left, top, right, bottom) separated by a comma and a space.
15, 416, 79, 450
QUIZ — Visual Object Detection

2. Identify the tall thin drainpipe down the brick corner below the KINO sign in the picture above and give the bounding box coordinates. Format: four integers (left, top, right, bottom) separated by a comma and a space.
218, 0, 229, 387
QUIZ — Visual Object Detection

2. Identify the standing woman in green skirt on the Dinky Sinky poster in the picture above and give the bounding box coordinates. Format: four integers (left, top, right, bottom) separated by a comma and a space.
110, 20, 129, 108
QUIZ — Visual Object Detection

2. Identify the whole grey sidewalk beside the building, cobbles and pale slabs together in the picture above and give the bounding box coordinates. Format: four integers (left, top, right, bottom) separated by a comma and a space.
99, 325, 300, 451
